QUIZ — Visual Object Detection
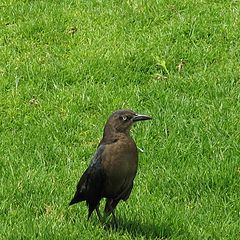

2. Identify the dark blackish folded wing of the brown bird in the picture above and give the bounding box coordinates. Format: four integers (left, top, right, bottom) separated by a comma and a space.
69, 145, 105, 205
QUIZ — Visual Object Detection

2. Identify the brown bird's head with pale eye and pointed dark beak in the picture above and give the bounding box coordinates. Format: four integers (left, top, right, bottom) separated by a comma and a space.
105, 110, 152, 133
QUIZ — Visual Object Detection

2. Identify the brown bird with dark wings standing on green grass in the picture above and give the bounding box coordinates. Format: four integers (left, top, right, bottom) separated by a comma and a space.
69, 109, 152, 224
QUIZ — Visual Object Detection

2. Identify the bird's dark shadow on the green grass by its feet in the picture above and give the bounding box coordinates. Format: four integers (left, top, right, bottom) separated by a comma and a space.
105, 218, 173, 239
